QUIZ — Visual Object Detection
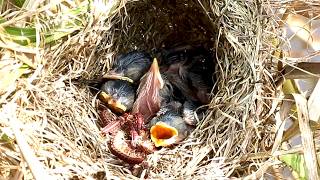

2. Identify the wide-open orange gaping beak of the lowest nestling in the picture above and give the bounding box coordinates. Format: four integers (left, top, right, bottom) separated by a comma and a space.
150, 122, 178, 147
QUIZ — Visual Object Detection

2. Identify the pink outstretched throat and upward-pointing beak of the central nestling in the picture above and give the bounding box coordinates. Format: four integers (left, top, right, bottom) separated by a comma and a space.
132, 58, 164, 123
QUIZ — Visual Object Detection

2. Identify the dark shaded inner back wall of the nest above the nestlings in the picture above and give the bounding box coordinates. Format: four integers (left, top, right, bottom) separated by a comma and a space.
106, 0, 217, 53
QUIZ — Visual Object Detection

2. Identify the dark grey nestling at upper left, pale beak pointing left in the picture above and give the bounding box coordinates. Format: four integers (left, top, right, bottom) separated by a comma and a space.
103, 51, 151, 83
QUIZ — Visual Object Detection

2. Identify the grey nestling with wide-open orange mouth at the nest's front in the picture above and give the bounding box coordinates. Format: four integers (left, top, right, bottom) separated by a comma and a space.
149, 101, 196, 147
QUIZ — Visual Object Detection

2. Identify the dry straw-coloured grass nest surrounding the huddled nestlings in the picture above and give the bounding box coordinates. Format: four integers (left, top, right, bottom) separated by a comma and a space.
1, 0, 276, 179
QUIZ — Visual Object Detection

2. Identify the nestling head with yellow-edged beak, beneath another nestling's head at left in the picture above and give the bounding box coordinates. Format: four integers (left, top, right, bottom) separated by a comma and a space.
99, 80, 135, 114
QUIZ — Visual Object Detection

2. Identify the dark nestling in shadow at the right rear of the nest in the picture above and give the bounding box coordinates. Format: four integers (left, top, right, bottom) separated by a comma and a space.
160, 46, 214, 104
